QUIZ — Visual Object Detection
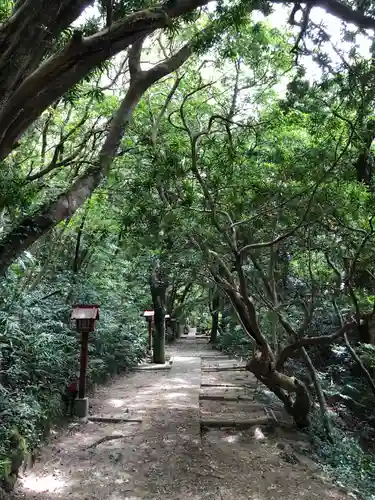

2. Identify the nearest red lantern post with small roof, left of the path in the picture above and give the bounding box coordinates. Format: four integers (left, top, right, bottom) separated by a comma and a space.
70, 304, 99, 417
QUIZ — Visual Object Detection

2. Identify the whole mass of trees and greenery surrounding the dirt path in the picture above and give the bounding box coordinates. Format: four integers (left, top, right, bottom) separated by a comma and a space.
0, 0, 375, 498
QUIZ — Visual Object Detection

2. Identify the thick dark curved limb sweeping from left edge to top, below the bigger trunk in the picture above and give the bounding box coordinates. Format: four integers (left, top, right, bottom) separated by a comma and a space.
0, 0, 208, 159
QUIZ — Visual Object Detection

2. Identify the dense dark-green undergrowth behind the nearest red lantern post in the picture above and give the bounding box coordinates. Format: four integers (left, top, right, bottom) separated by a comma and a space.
0, 266, 147, 486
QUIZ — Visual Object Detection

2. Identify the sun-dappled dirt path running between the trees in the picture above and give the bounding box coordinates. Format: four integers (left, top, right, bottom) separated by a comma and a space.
11, 338, 349, 500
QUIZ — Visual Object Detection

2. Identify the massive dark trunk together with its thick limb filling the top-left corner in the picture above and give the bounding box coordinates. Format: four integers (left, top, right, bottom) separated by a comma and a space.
0, 0, 208, 159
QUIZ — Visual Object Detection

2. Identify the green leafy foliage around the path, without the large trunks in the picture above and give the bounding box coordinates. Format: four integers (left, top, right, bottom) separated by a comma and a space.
0, 0, 375, 498
